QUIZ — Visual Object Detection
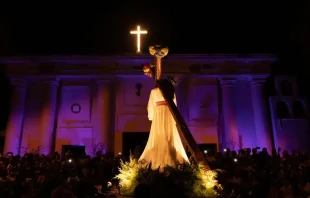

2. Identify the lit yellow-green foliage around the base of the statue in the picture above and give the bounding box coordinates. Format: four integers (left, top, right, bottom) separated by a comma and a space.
116, 157, 217, 198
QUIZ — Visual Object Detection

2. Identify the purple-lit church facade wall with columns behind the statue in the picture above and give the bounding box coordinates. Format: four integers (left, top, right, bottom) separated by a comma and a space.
5, 55, 309, 155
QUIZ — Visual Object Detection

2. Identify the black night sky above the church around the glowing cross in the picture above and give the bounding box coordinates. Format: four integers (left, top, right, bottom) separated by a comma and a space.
0, 0, 310, 128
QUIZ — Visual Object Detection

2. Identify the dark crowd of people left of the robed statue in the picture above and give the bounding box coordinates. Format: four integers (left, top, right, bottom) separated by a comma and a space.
0, 152, 120, 198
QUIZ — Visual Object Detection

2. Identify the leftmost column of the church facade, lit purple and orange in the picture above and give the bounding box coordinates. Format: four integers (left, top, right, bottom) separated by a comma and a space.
4, 79, 26, 155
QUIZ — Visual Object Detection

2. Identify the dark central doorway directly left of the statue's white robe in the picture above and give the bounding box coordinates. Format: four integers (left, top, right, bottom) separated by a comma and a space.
123, 132, 149, 157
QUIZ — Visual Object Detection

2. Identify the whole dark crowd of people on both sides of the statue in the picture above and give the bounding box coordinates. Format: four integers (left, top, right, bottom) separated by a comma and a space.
0, 148, 310, 198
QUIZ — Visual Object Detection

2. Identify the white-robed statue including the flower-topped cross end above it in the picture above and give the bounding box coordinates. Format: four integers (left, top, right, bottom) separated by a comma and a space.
139, 46, 189, 172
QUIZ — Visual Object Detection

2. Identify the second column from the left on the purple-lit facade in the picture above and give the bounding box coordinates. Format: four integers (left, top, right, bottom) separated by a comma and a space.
38, 79, 59, 155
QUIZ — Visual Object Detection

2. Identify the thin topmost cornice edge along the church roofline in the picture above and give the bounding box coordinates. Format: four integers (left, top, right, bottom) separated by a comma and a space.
0, 54, 277, 64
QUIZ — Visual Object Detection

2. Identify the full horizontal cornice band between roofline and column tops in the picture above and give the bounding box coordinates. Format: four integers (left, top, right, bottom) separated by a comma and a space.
0, 54, 276, 77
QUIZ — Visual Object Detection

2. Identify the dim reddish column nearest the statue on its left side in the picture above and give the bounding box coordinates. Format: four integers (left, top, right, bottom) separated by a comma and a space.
95, 80, 114, 153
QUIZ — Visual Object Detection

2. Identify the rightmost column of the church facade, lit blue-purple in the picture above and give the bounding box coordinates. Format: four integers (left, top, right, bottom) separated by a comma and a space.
250, 77, 272, 152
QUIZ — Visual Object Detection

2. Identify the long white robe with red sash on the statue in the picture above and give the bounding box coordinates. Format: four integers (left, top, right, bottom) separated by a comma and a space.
139, 88, 189, 171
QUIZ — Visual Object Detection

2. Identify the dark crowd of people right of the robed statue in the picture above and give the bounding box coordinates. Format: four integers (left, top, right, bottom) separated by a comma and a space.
209, 148, 310, 198
